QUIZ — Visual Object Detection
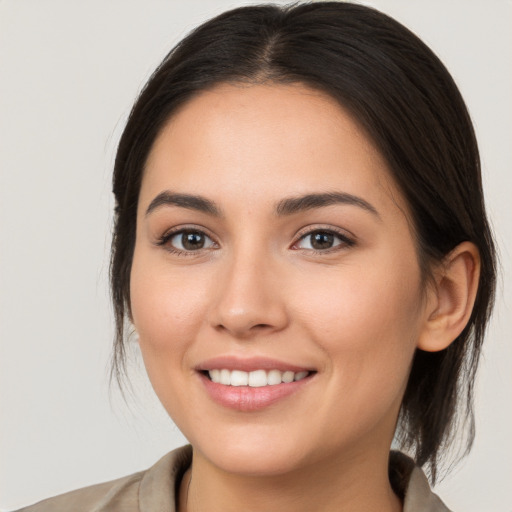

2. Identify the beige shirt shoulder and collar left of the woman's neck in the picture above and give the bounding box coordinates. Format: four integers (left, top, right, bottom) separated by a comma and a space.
12, 446, 192, 512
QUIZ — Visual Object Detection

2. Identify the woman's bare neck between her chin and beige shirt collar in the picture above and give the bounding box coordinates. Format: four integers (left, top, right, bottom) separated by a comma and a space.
179, 446, 402, 512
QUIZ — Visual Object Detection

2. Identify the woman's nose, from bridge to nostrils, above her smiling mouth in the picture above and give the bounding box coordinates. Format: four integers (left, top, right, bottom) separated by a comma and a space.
209, 251, 288, 339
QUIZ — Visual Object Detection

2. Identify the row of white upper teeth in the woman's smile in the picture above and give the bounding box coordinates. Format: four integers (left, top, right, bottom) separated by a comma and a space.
208, 369, 309, 388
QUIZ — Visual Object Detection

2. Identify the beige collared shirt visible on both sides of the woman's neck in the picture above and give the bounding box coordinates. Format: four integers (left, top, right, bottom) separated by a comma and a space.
14, 446, 450, 512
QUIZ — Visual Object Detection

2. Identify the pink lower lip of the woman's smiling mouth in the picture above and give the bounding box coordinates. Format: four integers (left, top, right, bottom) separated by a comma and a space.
199, 373, 313, 411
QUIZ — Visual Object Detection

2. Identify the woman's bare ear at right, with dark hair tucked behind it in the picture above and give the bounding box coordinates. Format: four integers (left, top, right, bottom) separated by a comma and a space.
418, 242, 480, 352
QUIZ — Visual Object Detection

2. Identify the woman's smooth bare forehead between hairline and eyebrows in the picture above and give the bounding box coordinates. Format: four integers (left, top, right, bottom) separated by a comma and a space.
141, 84, 400, 216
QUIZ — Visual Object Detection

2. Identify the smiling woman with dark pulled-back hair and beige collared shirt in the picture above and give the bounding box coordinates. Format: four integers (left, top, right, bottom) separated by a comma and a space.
13, 2, 495, 512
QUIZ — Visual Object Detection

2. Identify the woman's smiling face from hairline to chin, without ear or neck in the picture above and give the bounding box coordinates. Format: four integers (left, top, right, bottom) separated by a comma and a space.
131, 85, 426, 475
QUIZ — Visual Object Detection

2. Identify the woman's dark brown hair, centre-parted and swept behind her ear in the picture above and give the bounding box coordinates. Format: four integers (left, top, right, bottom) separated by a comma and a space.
110, 2, 496, 481
